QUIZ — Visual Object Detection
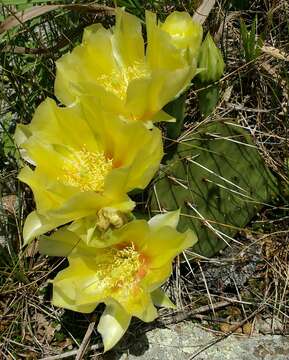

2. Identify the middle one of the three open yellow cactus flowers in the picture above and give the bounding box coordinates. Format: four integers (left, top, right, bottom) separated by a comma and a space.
15, 97, 163, 243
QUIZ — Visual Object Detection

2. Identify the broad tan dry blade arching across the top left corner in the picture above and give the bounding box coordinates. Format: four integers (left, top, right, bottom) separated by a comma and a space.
0, 4, 114, 34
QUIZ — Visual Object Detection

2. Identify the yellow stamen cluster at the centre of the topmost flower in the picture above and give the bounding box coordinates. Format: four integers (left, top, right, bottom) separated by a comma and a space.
97, 62, 149, 100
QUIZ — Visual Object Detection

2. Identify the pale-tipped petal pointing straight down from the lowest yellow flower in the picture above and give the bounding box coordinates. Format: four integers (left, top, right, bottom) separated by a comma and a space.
97, 303, 131, 352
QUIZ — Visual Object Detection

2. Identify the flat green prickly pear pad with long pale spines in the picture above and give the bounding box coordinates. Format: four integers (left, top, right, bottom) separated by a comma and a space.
150, 122, 278, 257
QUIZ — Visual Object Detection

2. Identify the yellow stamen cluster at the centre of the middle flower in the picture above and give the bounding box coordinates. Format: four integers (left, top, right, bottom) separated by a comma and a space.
62, 147, 113, 192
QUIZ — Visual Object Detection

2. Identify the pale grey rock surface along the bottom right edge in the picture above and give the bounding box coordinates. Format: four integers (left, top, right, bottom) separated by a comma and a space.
105, 322, 289, 360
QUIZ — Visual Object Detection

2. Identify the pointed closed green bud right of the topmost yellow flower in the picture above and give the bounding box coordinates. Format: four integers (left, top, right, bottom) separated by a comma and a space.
198, 33, 225, 84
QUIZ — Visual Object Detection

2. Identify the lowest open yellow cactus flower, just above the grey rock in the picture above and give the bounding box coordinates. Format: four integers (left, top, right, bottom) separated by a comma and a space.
40, 211, 197, 351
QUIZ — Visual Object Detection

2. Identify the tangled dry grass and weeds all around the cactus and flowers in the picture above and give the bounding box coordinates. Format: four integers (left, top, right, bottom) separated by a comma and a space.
0, 0, 289, 359
